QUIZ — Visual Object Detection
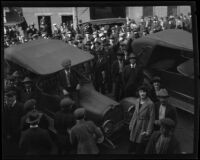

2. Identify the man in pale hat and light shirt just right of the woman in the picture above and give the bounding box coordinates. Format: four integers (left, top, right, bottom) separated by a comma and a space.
154, 88, 177, 130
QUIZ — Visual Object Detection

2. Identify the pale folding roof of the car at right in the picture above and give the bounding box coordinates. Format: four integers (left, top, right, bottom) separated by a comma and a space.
131, 29, 193, 66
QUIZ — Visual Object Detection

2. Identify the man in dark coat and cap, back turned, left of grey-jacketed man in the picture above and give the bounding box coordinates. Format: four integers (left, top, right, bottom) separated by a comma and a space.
54, 98, 76, 154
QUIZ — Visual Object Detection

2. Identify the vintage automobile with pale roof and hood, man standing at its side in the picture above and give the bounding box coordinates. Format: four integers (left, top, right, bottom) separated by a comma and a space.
4, 39, 124, 148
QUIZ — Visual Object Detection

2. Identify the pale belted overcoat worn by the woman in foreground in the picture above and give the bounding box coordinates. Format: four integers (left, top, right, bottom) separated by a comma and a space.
129, 98, 155, 143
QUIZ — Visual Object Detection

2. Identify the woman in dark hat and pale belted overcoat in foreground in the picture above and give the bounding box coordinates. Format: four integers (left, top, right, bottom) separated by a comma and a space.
129, 86, 155, 154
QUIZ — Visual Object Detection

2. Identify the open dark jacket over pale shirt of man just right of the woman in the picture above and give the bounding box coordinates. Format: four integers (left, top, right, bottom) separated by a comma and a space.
155, 102, 177, 124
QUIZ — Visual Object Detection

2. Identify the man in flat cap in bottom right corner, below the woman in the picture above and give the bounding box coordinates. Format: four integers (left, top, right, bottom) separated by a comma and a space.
145, 118, 181, 154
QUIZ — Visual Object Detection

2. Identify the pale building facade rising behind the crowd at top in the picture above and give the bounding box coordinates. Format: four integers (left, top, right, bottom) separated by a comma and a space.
22, 6, 191, 28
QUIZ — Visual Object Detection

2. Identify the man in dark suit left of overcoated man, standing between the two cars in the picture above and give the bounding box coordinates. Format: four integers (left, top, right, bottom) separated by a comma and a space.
111, 51, 125, 101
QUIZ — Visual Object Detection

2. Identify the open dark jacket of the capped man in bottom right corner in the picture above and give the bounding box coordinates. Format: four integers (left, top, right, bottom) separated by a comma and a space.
145, 131, 180, 154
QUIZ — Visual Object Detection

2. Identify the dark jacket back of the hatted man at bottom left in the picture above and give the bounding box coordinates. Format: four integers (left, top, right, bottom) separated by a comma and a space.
19, 127, 53, 155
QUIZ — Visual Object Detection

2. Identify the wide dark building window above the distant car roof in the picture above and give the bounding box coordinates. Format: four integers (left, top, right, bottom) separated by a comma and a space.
90, 7, 126, 19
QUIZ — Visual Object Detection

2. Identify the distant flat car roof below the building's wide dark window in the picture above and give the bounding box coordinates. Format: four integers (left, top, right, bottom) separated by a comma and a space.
79, 18, 126, 25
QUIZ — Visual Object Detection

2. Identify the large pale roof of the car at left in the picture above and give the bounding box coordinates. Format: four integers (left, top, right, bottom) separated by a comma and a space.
4, 39, 93, 75
